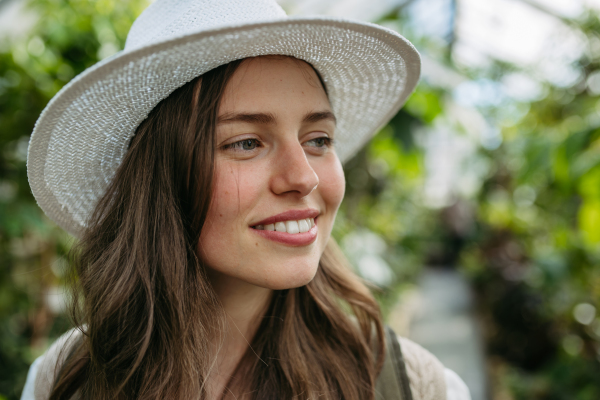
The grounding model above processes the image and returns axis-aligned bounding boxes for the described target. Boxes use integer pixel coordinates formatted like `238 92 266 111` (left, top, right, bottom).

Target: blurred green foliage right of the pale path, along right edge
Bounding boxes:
454 16 600 399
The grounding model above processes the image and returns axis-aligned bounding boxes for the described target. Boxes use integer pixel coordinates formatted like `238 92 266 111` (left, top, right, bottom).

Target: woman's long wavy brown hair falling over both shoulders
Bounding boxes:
50 60 384 400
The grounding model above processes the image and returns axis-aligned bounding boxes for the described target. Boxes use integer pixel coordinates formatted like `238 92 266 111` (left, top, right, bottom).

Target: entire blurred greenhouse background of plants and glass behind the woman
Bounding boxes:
0 0 600 400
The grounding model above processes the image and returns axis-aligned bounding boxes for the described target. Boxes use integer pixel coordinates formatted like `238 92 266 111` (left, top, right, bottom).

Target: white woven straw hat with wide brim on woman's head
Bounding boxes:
27 0 420 236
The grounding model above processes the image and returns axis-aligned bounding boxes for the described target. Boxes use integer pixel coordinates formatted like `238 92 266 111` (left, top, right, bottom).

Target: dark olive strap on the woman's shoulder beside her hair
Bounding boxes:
375 326 413 400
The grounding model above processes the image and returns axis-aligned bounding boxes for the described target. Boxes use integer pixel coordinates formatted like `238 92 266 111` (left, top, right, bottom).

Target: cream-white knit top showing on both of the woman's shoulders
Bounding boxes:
21 329 471 400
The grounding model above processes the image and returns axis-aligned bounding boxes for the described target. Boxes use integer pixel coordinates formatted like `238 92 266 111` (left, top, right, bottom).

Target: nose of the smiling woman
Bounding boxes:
271 143 319 197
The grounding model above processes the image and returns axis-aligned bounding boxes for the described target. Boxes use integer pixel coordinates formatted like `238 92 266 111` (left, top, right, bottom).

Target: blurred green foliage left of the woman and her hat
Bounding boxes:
0 0 146 399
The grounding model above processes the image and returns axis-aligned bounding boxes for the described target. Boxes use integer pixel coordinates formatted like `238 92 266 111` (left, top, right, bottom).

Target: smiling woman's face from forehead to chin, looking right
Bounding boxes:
198 57 345 289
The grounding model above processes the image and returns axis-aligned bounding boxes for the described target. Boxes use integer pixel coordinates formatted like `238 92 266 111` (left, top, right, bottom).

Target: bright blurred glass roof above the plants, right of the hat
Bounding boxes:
279 0 600 86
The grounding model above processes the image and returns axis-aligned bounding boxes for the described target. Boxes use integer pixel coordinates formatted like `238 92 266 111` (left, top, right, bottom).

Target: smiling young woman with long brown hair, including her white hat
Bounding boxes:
23 0 468 400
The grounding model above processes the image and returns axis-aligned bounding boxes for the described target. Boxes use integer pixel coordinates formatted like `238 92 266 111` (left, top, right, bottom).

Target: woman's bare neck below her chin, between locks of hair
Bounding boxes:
208 276 273 400
